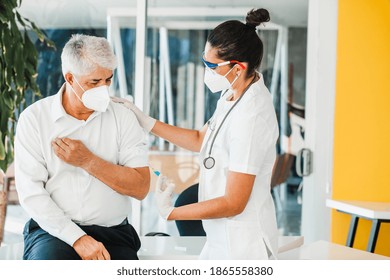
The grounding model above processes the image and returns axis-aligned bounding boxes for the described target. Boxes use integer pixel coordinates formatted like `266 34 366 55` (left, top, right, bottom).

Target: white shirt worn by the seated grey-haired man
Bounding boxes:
15 86 148 246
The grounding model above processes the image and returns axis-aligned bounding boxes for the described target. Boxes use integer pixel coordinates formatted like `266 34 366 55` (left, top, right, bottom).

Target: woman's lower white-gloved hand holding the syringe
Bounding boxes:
155 174 175 220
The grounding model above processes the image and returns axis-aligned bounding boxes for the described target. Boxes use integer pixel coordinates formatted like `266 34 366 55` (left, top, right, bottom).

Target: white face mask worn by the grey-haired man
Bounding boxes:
70 75 110 112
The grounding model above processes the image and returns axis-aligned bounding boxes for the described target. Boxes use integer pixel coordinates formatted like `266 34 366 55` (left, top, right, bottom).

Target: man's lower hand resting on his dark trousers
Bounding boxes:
73 235 111 260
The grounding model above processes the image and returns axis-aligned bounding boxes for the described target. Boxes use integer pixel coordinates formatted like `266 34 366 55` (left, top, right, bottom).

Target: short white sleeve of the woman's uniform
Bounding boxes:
228 114 275 175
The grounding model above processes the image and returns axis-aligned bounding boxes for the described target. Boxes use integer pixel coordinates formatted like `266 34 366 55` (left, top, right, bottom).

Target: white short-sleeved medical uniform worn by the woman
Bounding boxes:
199 75 279 259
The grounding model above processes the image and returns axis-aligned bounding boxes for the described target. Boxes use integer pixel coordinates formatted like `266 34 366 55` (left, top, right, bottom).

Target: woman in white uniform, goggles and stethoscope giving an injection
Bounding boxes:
114 9 279 259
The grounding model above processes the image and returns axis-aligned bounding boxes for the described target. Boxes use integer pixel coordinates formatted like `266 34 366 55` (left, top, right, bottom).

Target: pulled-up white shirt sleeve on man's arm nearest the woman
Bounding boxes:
118 110 148 168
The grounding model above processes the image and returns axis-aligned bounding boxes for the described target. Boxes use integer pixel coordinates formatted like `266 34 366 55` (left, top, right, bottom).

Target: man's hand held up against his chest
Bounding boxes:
51 138 94 168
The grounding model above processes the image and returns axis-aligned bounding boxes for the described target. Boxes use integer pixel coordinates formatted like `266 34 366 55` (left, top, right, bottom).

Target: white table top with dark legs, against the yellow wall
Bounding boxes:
326 199 390 220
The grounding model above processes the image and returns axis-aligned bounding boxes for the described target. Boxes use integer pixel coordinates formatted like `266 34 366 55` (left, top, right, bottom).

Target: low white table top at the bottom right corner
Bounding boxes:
278 240 390 260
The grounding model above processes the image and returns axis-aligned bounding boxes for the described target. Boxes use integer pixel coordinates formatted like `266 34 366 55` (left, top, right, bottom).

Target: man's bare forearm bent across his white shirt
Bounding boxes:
81 155 150 200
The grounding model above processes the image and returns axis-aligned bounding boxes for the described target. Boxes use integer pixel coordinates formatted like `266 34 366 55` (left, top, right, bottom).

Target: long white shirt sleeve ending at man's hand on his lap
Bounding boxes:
15 112 85 246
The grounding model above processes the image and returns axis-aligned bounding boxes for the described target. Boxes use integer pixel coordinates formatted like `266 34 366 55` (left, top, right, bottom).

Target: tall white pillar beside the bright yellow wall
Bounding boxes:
301 0 338 243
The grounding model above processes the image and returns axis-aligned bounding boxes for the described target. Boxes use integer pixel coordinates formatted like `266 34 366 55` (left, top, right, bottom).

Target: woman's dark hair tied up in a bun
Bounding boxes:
207 9 270 77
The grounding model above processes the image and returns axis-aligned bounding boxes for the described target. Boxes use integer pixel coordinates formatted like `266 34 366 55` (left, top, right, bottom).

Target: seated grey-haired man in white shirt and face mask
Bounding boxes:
15 35 150 260
